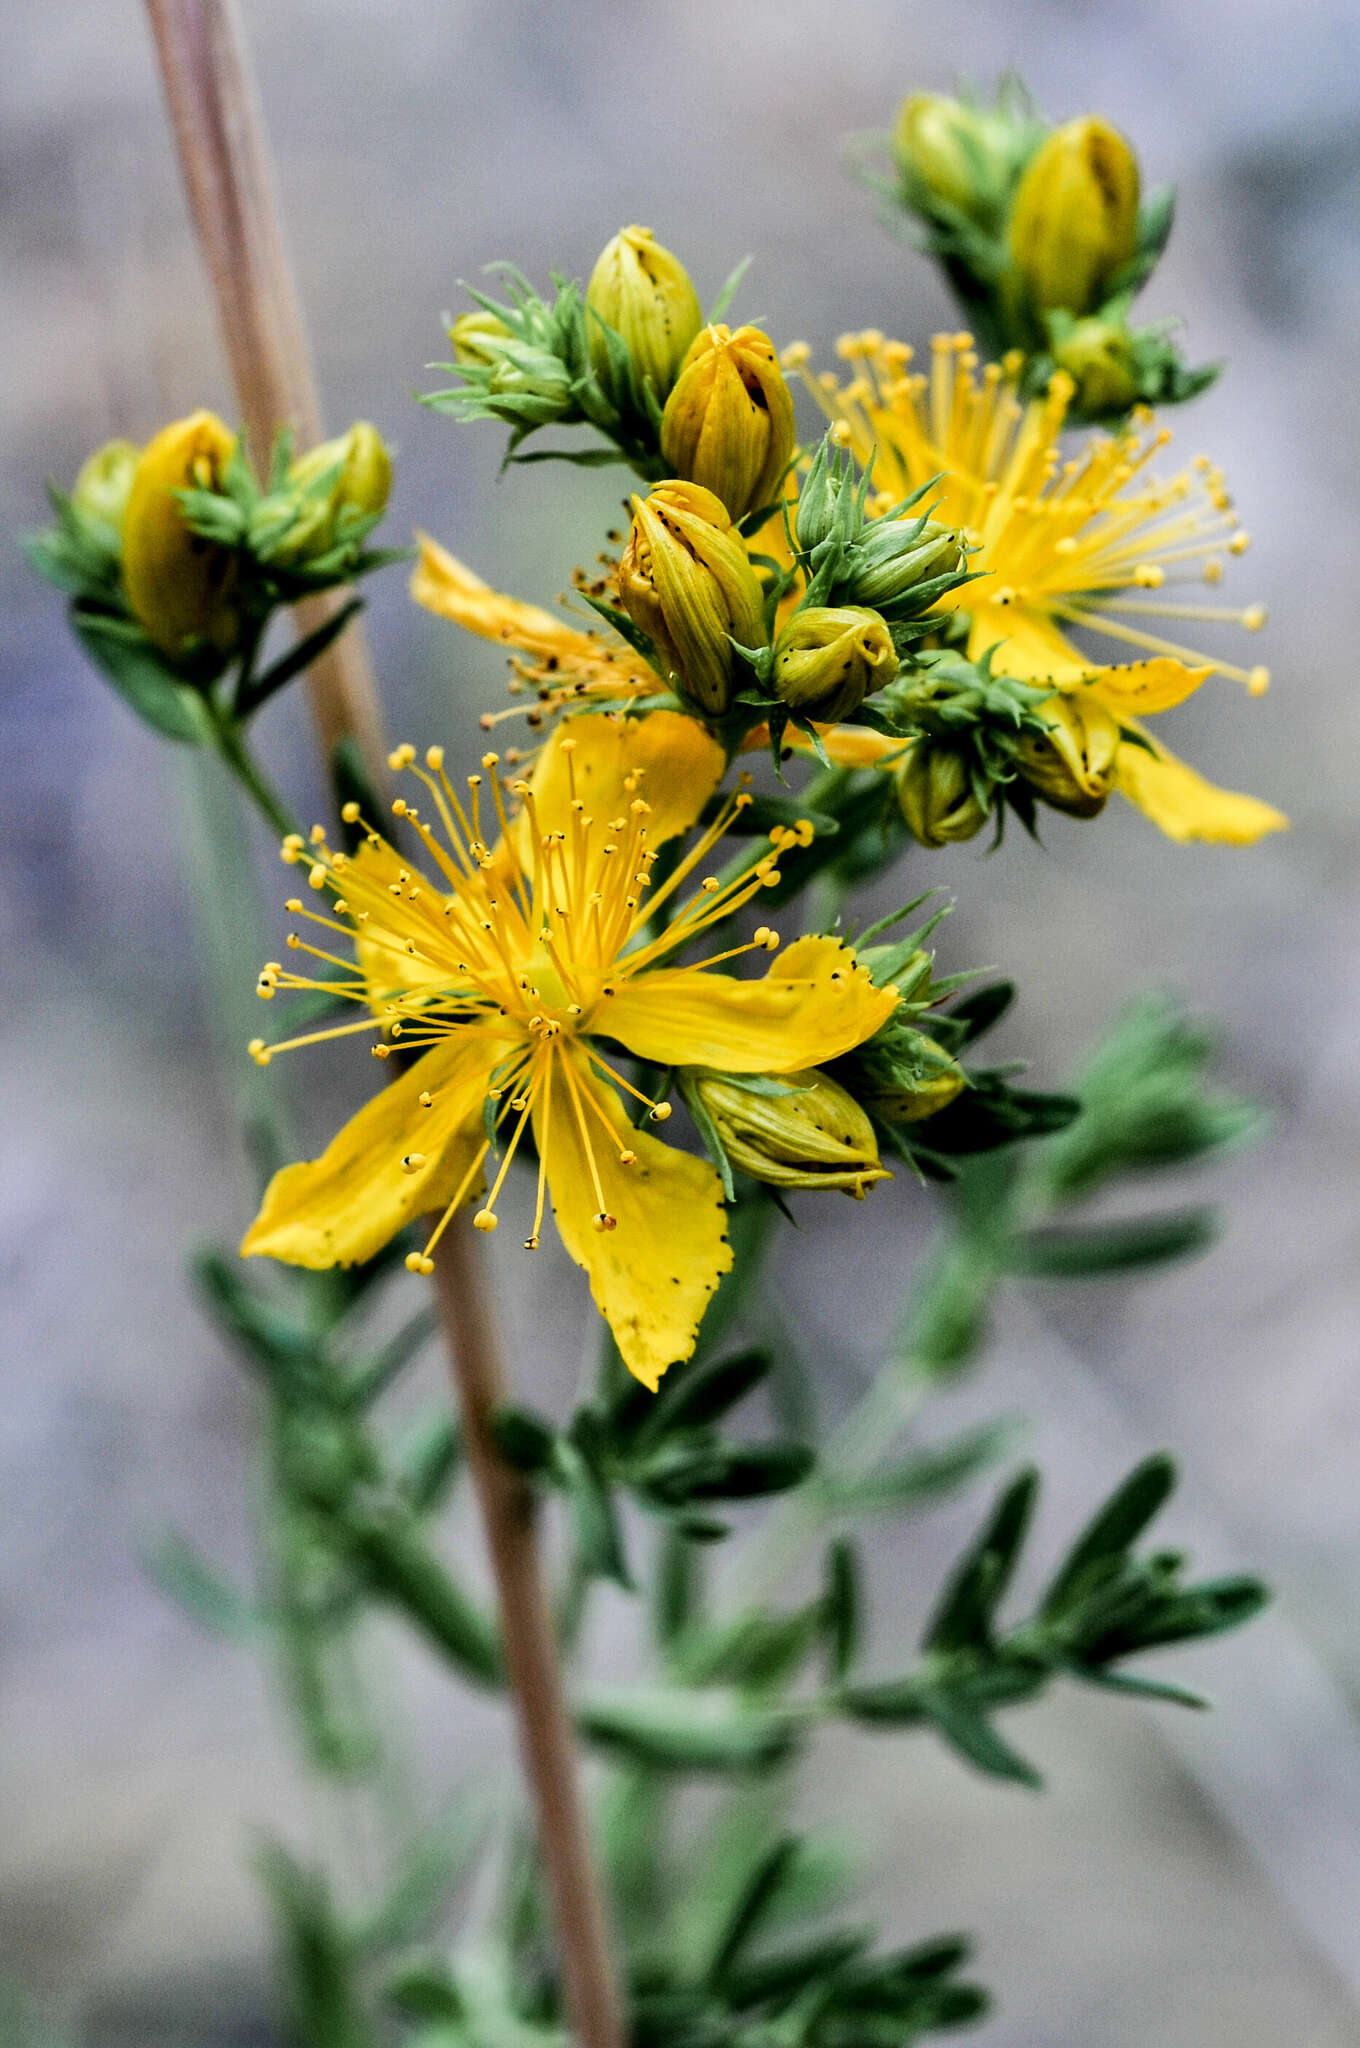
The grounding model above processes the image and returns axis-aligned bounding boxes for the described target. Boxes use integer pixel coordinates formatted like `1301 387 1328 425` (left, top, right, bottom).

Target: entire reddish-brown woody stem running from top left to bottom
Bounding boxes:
145 0 623 2048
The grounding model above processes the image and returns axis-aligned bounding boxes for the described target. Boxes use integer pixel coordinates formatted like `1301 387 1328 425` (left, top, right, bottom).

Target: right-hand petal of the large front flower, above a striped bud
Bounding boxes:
592 938 897 1073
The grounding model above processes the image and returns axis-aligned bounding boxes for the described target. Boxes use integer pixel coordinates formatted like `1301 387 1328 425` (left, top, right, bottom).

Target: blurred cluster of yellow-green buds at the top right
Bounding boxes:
891 80 1215 420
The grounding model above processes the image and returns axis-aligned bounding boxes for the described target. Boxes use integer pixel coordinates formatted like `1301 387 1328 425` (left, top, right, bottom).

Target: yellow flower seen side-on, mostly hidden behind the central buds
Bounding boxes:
412 532 666 731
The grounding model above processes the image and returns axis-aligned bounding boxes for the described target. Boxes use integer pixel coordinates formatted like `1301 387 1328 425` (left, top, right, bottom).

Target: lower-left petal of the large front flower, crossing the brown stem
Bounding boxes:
242 1030 504 1268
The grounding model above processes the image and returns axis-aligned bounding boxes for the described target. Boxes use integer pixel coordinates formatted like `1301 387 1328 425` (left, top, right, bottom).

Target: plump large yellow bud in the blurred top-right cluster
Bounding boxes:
1010 115 1139 313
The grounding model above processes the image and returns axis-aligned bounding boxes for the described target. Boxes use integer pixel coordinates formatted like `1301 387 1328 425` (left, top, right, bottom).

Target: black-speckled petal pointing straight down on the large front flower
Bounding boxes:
535 1047 731 1391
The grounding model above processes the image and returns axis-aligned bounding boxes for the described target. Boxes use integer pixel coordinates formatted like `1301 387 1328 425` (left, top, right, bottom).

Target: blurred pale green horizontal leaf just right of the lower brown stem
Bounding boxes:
576 1686 797 1772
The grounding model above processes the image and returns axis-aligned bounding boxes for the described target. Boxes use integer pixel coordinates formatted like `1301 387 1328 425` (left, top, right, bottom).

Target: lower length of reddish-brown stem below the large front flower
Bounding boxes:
434 1225 623 2048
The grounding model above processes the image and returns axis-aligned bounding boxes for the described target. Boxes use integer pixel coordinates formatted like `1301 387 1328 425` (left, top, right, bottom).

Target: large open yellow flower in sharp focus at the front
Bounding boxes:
242 713 897 1386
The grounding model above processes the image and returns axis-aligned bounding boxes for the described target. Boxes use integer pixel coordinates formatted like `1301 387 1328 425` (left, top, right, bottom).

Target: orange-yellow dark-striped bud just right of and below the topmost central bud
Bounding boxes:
662 326 797 520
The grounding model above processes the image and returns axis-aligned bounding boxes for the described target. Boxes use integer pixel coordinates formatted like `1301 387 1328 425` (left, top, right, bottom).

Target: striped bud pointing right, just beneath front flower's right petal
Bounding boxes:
692 1067 889 1200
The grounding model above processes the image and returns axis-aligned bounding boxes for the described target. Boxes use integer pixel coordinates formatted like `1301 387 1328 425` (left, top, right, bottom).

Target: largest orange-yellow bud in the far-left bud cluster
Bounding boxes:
123 412 240 662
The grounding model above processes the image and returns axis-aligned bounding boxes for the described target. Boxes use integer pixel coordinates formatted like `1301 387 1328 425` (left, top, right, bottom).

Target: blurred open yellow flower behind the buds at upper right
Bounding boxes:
787 332 1288 846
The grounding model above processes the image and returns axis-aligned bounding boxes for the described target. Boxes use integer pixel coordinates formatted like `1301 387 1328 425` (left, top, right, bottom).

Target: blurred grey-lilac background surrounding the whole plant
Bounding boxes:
0 0 1360 2048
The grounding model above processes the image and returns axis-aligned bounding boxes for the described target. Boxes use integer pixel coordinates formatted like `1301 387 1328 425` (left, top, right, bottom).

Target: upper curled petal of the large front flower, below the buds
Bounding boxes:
530 711 725 848
